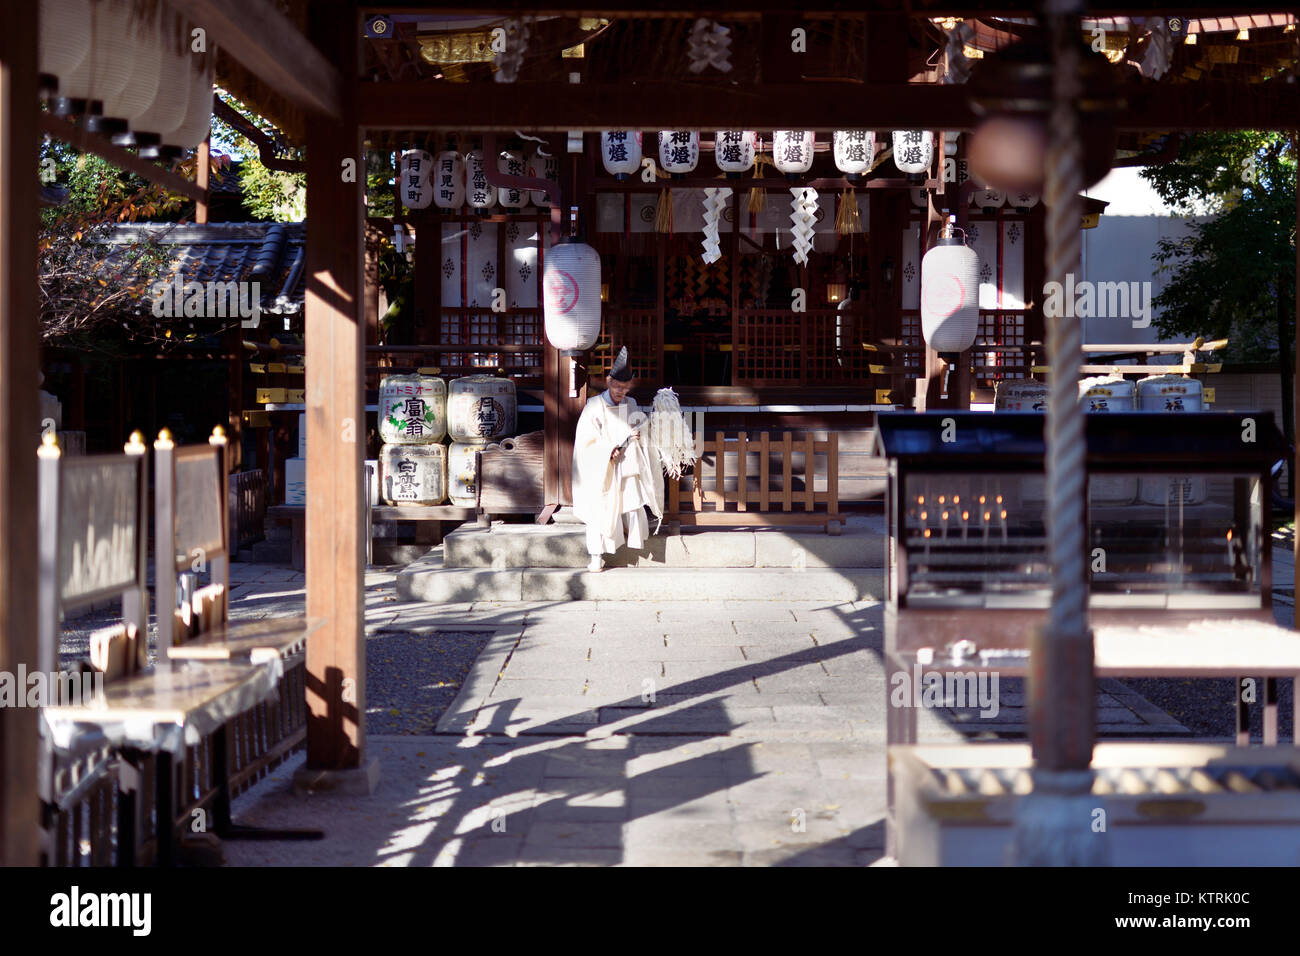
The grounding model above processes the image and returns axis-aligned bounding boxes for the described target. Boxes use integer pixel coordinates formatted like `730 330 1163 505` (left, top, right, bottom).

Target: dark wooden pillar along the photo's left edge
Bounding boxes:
0 5 40 866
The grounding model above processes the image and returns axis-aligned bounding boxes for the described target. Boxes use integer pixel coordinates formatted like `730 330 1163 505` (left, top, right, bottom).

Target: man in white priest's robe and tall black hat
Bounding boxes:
573 347 663 571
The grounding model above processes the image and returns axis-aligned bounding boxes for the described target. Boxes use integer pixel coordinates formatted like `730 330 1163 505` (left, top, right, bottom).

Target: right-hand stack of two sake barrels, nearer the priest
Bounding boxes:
447 375 519 506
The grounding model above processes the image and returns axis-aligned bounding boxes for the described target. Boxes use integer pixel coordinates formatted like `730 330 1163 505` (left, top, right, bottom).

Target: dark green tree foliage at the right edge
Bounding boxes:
1141 131 1296 363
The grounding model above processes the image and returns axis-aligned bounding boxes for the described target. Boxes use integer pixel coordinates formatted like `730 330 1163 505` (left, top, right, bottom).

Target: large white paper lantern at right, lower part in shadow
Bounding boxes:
920 216 979 364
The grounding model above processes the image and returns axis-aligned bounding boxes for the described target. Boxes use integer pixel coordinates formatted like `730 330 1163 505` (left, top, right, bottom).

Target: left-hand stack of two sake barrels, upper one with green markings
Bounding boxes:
380 375 447 505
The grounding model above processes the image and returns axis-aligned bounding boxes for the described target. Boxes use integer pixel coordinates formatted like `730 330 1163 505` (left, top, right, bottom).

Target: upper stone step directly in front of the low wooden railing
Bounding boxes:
443 516 887 571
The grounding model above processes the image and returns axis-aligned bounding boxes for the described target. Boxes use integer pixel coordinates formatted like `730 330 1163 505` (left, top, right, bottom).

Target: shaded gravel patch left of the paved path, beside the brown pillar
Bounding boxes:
365 628 493 735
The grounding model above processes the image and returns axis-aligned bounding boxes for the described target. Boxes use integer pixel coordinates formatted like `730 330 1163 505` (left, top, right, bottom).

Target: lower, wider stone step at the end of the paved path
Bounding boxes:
397 554 884 604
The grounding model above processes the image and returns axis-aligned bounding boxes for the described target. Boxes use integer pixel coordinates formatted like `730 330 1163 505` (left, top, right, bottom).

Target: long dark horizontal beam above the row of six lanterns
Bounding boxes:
358 81 1300 131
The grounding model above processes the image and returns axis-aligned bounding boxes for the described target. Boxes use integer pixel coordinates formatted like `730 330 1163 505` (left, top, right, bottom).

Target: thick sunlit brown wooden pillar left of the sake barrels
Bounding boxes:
306 1 365 771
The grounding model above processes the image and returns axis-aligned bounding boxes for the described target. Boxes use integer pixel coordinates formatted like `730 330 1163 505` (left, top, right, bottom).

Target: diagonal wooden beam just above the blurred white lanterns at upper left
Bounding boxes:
172 0 345 120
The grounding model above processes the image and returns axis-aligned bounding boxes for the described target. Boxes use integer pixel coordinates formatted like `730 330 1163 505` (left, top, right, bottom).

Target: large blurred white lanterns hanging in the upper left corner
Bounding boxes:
36 0 216 159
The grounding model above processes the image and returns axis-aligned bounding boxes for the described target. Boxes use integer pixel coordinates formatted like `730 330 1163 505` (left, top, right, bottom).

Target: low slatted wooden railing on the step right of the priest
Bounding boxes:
664 432 844 535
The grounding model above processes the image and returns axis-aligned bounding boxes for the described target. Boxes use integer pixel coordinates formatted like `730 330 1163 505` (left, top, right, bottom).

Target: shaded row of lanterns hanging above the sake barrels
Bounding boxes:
398 147 560 209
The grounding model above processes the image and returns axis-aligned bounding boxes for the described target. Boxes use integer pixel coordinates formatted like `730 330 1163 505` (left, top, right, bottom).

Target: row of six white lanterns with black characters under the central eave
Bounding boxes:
601 130 935 181
